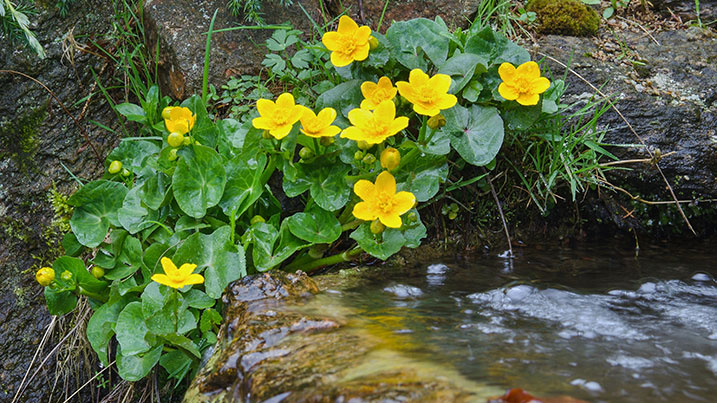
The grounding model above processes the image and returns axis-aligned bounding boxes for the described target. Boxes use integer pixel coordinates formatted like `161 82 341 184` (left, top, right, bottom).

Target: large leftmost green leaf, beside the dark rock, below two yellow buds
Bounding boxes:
68 180 127 248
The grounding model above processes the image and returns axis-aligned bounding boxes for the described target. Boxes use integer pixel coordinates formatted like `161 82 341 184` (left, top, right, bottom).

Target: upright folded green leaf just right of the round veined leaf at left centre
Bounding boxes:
219 154 267 218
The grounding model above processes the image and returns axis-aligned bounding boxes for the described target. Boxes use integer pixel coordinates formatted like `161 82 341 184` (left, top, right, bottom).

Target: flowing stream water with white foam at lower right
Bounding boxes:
321 244 717 402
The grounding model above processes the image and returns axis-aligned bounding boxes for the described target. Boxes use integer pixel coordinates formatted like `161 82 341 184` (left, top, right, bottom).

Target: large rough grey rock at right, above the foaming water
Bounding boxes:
535 28 717 234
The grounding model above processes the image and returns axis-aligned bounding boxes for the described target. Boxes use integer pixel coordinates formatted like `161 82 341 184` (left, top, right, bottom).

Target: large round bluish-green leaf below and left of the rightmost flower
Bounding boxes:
444 105 503 166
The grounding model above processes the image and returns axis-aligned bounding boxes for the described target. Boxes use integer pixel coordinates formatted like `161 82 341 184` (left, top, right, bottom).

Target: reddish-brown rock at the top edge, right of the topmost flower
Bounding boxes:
327 0 480 33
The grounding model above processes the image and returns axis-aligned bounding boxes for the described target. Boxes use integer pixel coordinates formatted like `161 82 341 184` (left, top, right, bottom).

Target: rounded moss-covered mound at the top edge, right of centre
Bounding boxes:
527 0 600 36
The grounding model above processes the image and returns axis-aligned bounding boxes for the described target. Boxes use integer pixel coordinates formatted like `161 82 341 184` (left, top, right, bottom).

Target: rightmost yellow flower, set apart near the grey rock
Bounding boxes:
498 61 550 105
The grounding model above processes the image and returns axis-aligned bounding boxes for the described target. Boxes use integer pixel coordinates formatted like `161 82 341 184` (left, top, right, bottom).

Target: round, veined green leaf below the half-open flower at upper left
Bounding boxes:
172 145 226 218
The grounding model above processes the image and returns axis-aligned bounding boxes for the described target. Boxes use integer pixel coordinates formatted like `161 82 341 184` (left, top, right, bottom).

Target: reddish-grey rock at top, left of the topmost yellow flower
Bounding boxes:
144 0 321 99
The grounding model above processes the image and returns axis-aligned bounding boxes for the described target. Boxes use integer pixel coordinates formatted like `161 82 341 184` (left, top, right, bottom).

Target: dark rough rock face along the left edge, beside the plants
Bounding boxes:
0 0 116 402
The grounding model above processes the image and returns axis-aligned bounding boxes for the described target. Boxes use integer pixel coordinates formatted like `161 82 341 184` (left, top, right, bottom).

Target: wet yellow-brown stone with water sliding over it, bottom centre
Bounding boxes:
184 270 495 402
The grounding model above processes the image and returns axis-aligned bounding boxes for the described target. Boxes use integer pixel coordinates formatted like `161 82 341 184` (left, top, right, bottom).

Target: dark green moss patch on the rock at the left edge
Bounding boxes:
0 107 46 170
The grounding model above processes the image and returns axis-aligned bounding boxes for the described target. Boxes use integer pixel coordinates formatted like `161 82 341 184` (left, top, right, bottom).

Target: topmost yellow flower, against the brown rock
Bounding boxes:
321 15 371 67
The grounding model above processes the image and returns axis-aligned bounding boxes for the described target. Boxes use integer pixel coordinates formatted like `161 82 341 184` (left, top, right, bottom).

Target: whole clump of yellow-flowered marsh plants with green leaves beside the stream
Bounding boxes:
36 16 576 388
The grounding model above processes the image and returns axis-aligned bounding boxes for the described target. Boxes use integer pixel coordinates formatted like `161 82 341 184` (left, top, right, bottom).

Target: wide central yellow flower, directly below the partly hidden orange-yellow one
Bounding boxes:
341 101 408 145
